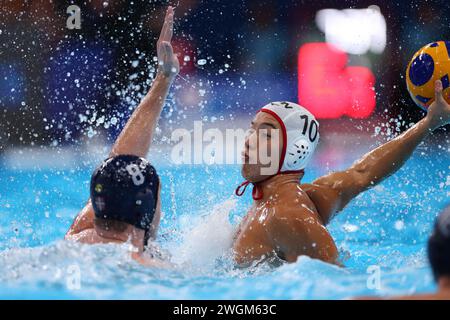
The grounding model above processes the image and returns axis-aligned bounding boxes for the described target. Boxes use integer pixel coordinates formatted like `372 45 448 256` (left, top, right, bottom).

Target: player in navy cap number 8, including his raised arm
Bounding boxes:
66 7 179 267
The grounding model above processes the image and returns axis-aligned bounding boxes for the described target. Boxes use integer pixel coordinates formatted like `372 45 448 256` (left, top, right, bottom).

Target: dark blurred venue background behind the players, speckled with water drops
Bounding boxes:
0 0 450 152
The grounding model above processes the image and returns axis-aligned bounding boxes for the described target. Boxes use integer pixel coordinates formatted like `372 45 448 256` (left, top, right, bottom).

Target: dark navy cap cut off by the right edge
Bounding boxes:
428 206 450 281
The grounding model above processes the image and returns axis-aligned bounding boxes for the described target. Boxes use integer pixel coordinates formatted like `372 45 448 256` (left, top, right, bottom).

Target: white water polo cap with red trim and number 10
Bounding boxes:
236 101 319 200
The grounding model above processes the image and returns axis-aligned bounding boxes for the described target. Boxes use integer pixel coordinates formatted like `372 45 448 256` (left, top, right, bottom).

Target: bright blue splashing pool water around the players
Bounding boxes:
0 146 450 299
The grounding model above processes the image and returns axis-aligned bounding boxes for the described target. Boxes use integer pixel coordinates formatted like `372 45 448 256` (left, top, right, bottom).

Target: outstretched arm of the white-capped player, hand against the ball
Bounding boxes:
306 81 450 223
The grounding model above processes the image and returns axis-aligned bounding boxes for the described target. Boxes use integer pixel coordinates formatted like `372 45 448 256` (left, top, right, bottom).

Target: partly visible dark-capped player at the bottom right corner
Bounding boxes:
358 206 450 300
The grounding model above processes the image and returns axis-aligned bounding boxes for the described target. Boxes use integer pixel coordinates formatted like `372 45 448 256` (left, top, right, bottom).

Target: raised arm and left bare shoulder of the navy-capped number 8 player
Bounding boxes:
66 7 180 238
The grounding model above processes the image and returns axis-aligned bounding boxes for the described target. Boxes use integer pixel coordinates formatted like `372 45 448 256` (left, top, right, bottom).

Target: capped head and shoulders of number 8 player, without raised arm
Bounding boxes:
67 155 164 265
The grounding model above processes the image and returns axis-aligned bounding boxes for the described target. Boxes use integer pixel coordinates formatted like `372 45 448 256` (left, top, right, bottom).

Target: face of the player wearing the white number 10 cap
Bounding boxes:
241 112 283 183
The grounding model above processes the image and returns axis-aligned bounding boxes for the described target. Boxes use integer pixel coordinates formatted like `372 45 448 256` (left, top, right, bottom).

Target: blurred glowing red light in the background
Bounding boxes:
298 43 376 119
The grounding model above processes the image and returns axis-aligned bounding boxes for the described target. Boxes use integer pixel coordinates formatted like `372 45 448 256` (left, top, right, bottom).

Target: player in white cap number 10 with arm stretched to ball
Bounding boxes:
233 81 450 266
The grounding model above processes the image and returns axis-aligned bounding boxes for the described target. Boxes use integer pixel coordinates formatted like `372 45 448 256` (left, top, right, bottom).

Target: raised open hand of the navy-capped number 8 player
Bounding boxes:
157 6 180 80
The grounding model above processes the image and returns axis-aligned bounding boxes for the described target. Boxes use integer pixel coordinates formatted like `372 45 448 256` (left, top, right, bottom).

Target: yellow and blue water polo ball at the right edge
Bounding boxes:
406 41 450 110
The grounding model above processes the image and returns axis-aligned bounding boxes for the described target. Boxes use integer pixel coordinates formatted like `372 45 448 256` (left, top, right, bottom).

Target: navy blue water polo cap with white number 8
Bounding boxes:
90 155 159 232
